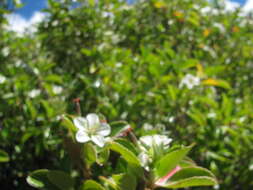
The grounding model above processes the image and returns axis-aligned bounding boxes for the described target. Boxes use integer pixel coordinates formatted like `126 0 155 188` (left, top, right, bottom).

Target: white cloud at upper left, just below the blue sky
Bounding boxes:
6 11 46 35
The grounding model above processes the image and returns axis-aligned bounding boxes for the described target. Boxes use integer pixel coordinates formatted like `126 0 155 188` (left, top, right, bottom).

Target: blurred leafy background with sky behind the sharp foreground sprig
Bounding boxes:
0 0 253 190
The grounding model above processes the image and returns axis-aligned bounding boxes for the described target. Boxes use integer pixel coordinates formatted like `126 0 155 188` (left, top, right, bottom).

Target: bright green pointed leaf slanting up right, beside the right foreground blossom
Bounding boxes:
155 145 193 178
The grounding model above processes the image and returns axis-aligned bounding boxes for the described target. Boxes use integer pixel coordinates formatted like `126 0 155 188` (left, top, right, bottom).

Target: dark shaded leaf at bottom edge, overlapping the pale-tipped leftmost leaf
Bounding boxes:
47 170 74 190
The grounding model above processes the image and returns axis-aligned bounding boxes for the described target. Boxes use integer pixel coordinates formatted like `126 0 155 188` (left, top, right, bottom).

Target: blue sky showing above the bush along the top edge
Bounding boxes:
16 0 247 19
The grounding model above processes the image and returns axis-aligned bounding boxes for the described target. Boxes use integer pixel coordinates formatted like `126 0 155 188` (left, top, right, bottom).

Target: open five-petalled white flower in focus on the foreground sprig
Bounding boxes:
74 113 111 147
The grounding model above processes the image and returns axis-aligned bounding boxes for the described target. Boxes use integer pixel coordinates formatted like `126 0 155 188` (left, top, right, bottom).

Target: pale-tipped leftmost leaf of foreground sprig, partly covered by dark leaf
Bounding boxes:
26 169 59 190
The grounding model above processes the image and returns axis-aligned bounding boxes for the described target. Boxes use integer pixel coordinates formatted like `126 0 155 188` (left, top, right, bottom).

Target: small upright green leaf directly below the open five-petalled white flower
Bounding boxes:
82 143 97 165
